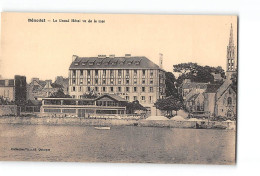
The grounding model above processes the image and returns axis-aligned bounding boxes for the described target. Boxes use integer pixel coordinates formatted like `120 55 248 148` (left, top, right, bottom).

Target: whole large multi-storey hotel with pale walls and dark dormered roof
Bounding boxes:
69 54 166 107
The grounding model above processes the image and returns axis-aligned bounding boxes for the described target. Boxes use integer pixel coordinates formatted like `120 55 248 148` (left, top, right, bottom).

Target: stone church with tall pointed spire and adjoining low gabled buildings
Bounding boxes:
182 24 237 119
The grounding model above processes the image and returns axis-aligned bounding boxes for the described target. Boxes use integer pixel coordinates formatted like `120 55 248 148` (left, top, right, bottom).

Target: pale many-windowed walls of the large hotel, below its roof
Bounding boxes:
69 68 165 107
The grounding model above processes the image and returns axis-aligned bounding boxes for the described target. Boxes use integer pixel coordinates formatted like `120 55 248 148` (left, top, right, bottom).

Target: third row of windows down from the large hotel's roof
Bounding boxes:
71 86 153 92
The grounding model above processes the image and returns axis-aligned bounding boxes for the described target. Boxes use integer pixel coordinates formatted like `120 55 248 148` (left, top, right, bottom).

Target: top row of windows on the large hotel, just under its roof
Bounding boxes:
72 69 153 76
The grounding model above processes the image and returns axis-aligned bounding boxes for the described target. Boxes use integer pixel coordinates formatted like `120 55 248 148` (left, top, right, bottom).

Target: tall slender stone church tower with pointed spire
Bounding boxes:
227 24 237 80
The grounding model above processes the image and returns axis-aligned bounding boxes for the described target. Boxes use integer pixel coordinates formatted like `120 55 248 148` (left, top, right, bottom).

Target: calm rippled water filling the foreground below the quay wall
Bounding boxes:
0 124 235 164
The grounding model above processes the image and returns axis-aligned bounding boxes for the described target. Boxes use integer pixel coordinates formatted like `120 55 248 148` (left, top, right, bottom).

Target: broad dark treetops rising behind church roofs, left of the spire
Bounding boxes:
173 62 225 84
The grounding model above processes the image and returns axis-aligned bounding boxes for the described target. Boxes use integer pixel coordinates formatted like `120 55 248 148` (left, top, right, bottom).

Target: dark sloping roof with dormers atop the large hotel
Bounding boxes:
69 56 160 69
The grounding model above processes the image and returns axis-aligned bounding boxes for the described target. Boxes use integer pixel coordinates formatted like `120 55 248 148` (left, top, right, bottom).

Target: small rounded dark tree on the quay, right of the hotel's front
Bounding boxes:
154 96 183 117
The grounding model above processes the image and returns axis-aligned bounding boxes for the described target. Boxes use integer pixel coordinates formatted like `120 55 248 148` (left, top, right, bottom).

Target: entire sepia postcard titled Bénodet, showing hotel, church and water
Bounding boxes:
0 12 238 165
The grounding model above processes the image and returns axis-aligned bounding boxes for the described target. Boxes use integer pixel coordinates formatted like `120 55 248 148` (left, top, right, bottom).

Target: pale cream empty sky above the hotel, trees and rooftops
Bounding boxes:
0 13 237 82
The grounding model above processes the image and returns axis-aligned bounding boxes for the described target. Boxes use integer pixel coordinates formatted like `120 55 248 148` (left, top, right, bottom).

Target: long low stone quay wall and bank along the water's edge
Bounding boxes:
0 117 236 130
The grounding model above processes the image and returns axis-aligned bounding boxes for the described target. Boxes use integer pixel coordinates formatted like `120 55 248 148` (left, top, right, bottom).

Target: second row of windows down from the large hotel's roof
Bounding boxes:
72 78 153 84
